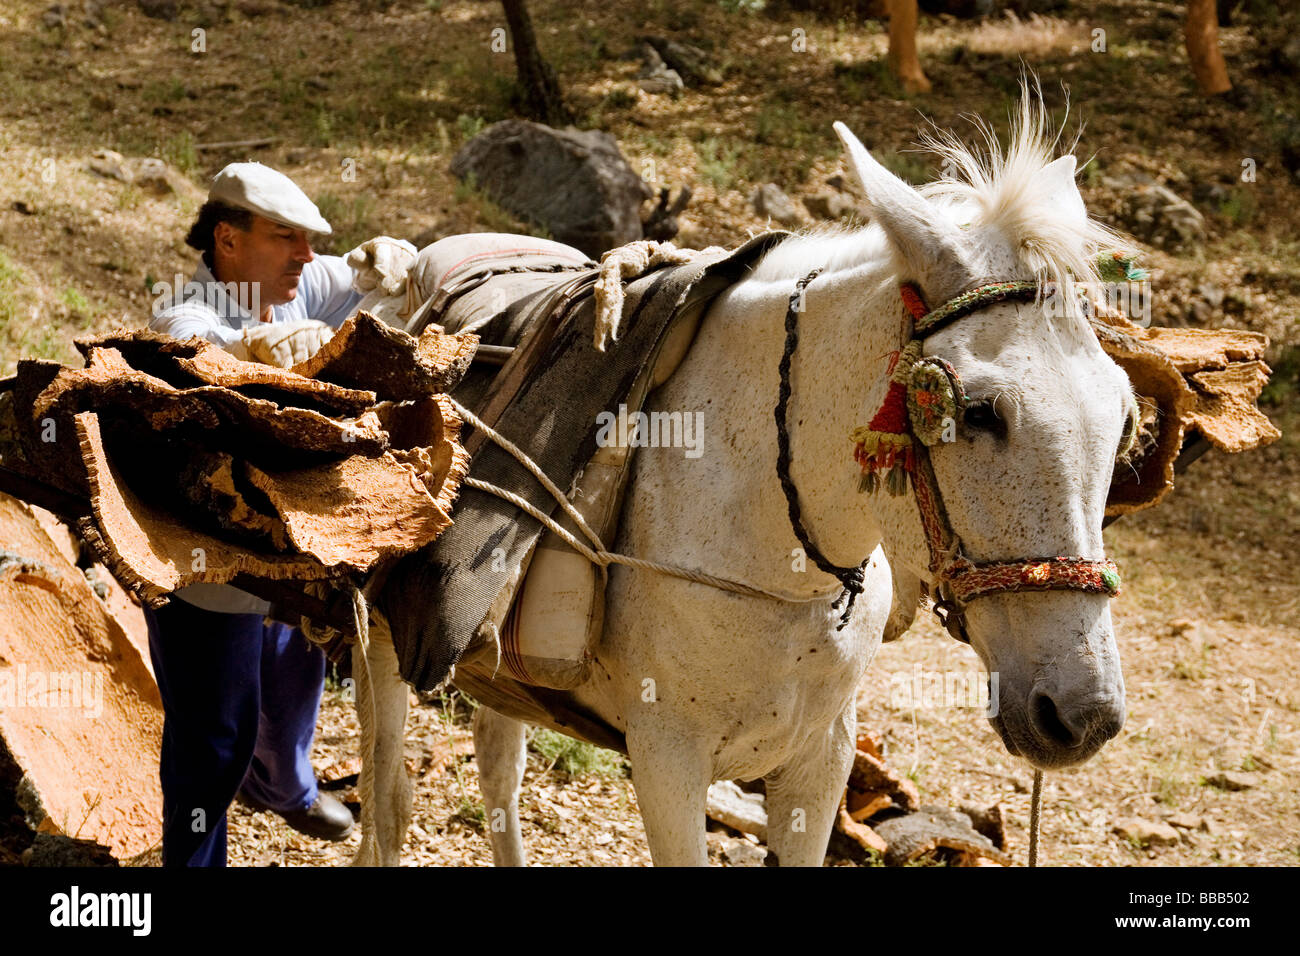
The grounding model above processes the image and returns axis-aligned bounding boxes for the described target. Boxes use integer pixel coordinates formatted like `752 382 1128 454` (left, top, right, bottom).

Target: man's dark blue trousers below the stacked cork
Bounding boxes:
144 598 325 866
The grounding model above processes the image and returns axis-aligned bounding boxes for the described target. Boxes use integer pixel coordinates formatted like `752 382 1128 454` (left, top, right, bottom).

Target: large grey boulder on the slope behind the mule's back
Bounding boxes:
451 120 654 259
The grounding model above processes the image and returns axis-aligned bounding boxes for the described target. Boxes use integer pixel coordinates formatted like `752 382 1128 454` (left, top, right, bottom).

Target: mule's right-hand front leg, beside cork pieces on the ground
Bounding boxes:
763 700 857 866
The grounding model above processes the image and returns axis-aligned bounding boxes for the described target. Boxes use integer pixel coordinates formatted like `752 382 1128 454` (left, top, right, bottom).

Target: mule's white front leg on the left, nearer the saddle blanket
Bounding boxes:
628 726 712 866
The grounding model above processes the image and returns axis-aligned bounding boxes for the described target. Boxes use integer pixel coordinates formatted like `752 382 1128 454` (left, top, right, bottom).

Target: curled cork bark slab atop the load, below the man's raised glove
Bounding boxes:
290 312 478 402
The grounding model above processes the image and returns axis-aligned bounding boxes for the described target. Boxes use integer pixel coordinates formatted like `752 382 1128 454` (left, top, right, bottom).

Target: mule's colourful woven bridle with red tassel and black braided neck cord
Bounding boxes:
776 269 1119 644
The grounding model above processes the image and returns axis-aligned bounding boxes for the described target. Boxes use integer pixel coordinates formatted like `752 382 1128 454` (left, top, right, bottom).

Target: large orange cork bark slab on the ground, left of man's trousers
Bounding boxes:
0 496 163 858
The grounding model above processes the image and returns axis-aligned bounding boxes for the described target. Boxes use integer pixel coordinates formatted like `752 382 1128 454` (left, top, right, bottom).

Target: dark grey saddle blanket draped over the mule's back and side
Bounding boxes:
378 233 787 691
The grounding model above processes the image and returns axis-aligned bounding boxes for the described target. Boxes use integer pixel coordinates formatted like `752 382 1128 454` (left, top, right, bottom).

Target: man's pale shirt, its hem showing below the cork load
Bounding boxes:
150 256 363 614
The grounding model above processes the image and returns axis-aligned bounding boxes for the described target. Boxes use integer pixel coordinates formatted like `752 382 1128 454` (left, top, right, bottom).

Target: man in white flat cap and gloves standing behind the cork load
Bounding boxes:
146 163 415 866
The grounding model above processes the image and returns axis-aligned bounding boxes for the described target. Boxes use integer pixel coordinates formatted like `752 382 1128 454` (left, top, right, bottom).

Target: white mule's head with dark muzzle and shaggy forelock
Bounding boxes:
836 114 1135 769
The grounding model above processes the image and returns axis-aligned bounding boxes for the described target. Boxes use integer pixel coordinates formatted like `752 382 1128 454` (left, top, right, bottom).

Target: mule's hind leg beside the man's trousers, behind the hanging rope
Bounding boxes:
352 615 411 866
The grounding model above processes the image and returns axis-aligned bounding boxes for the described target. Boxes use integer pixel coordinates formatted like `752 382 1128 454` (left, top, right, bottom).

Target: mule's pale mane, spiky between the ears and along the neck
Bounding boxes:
754 92 1127 303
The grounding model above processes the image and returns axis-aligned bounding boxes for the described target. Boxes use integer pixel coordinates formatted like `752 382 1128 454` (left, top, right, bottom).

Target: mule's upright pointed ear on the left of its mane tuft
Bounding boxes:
835 122 970 299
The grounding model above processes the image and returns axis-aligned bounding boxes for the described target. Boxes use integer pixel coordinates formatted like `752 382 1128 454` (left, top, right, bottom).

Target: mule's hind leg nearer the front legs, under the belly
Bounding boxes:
475 706 528 866
